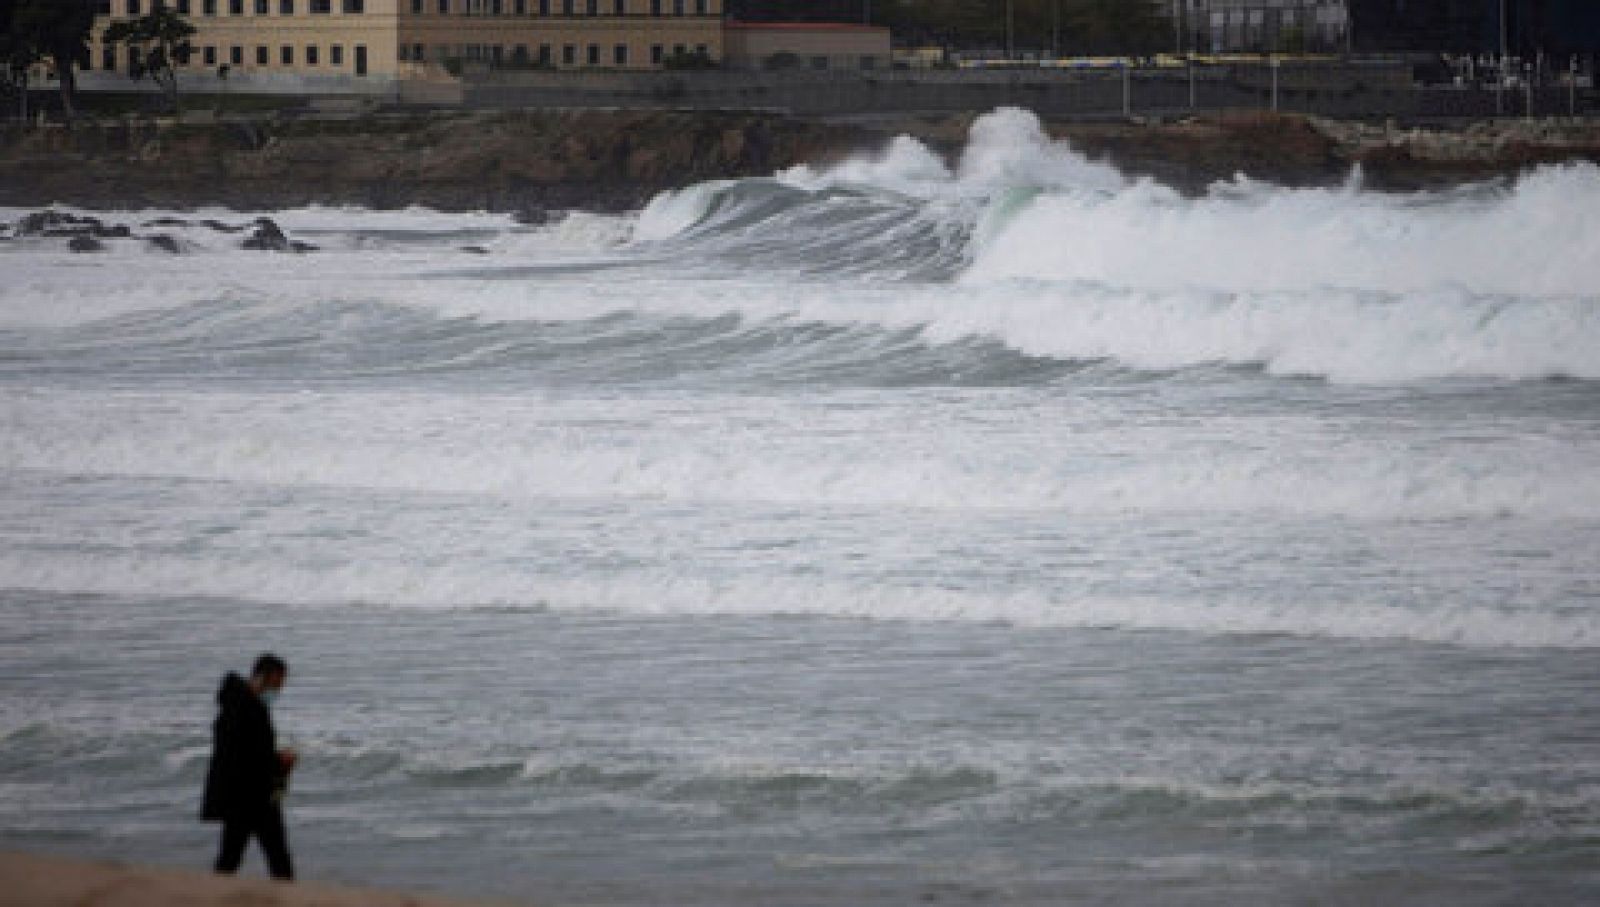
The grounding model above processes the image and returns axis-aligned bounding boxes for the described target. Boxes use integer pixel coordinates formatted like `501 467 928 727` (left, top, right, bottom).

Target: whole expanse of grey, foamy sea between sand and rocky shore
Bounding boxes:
0 110 1600 905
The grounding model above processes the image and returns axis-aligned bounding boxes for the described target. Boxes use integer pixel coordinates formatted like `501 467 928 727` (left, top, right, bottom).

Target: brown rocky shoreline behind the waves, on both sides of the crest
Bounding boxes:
0 109 1600 219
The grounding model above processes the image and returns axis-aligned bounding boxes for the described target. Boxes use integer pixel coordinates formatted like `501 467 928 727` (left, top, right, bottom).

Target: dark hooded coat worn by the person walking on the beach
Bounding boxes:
200 673 283 821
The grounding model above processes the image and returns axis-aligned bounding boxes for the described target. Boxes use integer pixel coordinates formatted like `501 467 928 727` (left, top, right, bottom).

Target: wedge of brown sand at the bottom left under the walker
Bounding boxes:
0 853 524 907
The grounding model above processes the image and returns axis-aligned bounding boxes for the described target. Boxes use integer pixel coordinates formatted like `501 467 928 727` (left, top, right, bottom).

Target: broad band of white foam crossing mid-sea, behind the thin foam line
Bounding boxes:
0 392 1600 520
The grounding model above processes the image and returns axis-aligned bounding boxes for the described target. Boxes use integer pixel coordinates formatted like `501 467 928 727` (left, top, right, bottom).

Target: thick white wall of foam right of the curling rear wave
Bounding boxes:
965 163 1600 299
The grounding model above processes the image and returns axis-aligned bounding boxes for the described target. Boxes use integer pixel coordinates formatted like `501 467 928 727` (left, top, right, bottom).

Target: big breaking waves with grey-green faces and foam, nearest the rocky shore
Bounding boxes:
0 110 1600 386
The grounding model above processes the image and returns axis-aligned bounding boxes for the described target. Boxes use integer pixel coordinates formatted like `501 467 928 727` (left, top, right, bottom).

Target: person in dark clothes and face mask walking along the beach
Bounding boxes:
200 654 294 881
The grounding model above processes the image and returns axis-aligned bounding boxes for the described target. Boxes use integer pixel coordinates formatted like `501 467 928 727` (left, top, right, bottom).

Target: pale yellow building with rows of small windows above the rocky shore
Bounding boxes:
86 0 723 82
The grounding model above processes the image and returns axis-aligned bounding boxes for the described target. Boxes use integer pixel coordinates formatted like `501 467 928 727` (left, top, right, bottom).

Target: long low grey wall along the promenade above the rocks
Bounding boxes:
461 64 1597 120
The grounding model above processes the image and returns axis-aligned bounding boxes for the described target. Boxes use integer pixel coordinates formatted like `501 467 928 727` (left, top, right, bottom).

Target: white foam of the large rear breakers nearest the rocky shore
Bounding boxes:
0 110 1600 382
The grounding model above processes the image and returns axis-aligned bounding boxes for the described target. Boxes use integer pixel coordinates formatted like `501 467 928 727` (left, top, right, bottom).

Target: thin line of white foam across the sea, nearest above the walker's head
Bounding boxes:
0 553 1600 648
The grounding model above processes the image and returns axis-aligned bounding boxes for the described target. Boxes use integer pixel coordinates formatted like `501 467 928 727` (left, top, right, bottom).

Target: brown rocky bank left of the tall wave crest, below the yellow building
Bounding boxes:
0 110 875 218
